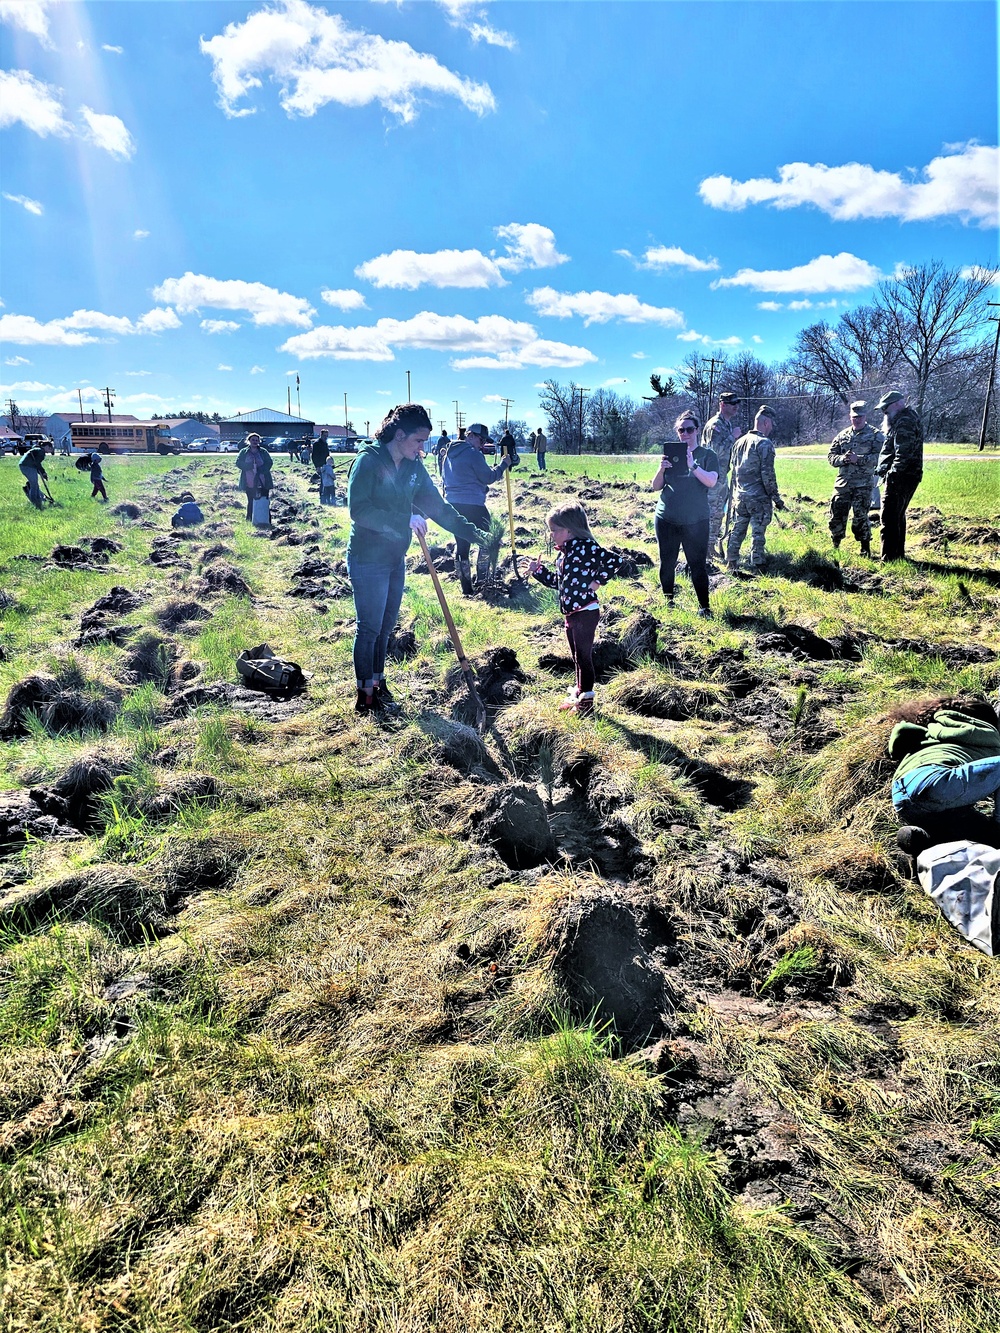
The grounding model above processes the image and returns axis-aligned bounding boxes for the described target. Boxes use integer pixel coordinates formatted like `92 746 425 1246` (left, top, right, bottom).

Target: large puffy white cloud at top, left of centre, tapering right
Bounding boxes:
201 0 496 121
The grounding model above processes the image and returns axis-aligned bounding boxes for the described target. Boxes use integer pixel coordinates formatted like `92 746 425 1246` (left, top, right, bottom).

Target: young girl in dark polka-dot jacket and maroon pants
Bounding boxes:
528 504 623 716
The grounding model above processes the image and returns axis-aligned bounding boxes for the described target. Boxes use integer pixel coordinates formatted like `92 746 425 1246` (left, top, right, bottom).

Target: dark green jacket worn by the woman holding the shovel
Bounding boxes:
347 440 488 565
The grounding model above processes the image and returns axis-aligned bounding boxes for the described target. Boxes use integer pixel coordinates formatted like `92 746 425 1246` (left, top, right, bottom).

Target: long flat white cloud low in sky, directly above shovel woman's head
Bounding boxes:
279 311 596 369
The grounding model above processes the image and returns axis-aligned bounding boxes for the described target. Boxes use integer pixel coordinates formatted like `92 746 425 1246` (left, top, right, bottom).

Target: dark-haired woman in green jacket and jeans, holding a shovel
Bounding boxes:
347 403 487 714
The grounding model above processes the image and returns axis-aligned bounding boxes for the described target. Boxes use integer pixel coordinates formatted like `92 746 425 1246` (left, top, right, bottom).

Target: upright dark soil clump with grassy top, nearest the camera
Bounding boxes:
547 888 679 1050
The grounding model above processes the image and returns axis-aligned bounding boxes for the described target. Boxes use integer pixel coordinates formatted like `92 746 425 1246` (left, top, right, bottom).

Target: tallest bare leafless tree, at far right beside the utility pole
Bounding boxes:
876 260 999 416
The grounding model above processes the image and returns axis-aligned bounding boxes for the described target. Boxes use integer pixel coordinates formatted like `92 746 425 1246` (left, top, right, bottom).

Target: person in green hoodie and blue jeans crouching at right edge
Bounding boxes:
889 696 1000 856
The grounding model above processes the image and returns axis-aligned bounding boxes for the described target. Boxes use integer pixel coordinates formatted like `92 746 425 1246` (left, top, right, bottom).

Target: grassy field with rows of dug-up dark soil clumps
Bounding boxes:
0 455 1000 1333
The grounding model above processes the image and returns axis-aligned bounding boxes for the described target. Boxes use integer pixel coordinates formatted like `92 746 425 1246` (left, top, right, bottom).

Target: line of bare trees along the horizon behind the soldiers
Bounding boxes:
539 260 1000 453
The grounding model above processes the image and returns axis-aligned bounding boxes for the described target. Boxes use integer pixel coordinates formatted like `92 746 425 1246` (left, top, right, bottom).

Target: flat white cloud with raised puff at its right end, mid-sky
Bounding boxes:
355 223 569 292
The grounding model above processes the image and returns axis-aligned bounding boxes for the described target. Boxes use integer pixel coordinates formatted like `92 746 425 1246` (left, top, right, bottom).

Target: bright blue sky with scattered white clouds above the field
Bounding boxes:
0 0 997 428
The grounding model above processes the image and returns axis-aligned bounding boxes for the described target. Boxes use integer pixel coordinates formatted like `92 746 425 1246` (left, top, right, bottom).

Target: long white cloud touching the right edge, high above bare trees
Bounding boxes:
700 140 1000 227
